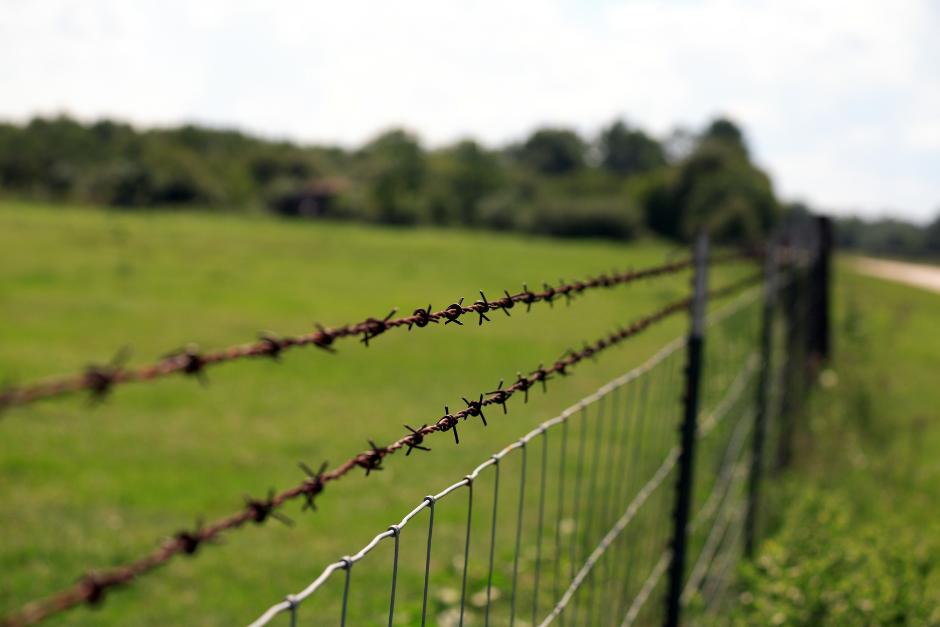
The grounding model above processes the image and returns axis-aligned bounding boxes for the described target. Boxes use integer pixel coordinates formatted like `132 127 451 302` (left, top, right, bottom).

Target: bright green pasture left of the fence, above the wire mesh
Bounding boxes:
0 203 756 625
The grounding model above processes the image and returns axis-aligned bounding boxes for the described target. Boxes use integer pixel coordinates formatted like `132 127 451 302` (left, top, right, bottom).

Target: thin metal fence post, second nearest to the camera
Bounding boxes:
744 240 777 558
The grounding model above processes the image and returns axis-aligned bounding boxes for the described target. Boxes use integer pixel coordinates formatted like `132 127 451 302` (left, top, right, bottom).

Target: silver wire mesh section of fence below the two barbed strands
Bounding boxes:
252 218 828 626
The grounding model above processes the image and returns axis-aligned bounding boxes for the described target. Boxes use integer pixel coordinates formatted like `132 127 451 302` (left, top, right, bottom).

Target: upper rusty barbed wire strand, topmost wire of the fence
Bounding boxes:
0 251 756 411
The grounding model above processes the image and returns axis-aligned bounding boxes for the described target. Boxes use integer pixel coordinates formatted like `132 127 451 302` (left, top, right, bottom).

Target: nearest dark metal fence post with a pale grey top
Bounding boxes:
664 234 708 627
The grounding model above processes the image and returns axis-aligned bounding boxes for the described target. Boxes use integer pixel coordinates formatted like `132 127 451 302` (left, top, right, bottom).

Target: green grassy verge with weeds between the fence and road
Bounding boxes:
717 268 940 625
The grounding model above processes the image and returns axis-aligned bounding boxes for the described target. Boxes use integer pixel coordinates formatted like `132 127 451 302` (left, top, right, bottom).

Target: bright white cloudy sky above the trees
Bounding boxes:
0 0 940 221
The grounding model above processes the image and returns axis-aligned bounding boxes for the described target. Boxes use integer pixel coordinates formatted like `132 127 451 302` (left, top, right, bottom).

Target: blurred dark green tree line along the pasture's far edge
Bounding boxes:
0 116 808 247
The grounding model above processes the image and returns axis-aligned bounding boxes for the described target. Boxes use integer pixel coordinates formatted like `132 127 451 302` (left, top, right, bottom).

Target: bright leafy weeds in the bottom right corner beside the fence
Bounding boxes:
723 494 940 625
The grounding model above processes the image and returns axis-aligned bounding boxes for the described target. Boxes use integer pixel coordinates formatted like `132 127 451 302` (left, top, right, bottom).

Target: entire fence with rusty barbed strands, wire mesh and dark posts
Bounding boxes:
0 219 831 626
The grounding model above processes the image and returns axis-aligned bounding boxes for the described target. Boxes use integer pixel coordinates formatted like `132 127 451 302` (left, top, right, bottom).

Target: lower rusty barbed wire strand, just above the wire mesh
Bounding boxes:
0 273 763 627
